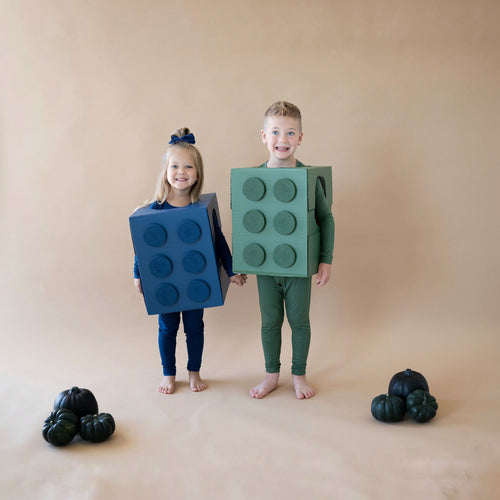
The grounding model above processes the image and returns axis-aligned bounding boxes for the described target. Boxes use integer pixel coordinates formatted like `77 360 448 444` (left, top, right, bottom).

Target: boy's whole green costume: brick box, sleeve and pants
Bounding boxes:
231 161 335 375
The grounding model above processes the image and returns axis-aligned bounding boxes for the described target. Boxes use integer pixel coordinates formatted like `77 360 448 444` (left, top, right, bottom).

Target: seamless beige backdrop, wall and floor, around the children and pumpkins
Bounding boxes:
0 0 500 499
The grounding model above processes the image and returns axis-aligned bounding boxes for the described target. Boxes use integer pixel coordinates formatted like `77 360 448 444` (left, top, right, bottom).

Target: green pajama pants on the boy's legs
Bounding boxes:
257 275 311 375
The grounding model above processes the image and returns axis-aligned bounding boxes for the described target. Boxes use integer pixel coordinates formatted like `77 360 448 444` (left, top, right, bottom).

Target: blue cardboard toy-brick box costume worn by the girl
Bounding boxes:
129 193 229 314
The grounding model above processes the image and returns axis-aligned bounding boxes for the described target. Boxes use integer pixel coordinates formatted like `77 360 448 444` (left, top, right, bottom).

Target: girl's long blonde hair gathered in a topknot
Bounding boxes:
136 127 203 210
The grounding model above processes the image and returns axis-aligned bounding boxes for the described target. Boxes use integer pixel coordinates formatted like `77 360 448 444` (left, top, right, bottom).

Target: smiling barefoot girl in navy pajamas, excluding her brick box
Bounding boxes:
134 128 246 394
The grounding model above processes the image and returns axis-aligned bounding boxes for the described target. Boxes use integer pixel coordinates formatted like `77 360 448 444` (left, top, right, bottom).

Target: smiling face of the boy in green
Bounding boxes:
261 116 302 162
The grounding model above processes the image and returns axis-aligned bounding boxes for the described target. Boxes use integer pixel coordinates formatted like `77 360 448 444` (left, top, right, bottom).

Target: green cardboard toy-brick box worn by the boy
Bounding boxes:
231 166 333 277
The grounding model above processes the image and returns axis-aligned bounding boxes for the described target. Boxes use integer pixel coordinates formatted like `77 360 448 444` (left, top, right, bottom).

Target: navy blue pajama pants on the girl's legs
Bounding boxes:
158 309 204 375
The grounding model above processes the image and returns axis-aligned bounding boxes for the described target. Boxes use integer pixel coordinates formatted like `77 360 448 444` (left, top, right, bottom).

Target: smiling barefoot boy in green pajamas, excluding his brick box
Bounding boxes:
250 101 335 399
